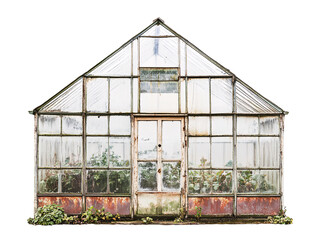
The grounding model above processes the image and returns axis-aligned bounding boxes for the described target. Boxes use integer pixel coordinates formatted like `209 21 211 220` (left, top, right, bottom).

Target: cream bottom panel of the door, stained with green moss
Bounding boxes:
137 193 181 215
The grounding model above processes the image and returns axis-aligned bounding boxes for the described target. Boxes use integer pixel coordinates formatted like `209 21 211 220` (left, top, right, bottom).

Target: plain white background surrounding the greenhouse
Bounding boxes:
0 0 319 239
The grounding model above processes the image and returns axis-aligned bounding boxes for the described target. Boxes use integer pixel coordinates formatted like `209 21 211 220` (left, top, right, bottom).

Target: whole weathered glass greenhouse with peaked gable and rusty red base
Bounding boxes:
30 18 287 218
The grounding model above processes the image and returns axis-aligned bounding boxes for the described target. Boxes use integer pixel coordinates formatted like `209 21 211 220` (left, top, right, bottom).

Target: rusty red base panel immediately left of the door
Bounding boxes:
86 197 131 216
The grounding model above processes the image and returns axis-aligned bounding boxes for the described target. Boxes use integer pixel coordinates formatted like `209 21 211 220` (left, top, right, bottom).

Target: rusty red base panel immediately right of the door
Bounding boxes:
188 197 233 215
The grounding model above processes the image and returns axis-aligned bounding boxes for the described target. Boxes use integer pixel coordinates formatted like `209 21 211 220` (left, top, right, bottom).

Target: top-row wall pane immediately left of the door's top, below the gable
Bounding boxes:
110 116 131 135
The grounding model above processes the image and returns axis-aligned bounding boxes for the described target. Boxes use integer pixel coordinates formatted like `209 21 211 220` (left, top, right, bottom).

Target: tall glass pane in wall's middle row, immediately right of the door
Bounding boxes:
188 137 210 168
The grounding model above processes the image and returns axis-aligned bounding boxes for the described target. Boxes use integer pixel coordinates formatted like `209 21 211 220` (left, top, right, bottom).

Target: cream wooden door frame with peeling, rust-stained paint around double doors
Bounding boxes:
131 115 187 218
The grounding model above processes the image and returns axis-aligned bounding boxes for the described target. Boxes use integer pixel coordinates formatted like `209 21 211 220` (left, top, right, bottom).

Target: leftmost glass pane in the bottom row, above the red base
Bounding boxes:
38 170 59 193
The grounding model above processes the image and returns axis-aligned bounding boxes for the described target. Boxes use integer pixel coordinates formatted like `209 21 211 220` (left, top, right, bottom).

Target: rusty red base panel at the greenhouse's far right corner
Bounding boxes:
237 197 280 215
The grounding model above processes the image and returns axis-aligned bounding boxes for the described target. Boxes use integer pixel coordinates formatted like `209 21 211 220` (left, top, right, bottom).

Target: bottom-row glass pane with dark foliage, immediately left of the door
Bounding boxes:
109 170 131 193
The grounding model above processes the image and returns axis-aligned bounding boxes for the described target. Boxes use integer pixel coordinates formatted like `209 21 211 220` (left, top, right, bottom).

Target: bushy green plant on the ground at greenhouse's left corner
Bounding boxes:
28 204 64 225
